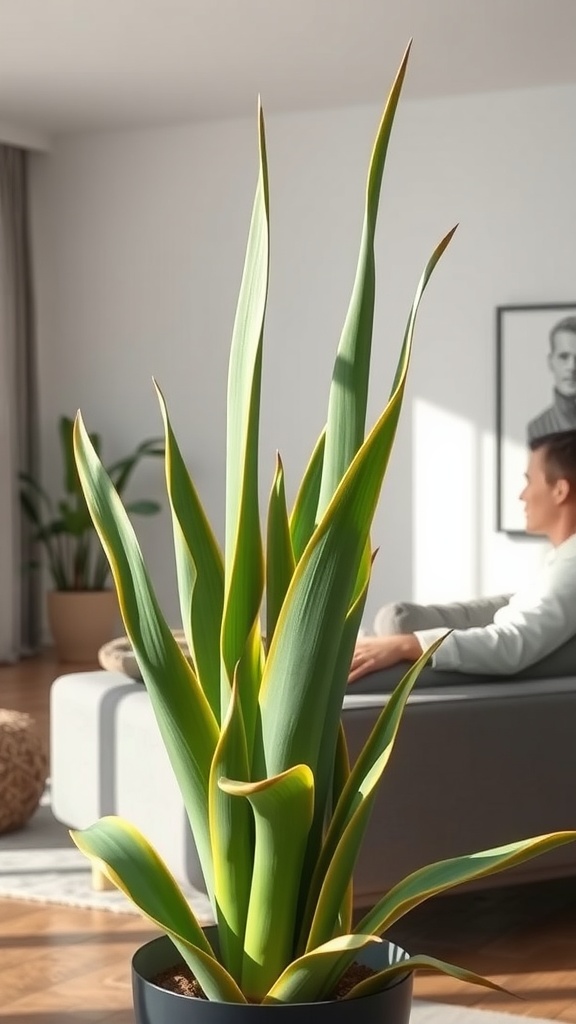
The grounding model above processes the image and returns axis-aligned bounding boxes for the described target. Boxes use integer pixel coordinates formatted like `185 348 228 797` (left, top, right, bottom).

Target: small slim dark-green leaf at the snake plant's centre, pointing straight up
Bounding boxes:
266 455 294 643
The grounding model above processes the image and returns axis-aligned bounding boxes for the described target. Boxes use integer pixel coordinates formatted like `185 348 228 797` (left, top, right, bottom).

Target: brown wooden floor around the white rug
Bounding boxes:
0 654 576 1024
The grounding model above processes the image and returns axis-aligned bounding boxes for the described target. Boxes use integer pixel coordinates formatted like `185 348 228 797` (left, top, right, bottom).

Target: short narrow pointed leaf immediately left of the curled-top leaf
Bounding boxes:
209 683 250 983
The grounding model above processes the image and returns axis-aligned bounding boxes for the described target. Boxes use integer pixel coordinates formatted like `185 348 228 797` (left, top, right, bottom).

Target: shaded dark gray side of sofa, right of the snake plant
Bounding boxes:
343 673 576 905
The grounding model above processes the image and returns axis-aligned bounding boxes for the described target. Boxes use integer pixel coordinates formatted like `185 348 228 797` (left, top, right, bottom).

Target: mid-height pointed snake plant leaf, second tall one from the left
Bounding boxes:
155 382 224 721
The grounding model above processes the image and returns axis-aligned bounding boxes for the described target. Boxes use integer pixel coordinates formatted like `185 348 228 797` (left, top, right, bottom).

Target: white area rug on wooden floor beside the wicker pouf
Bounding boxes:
0 795 212 925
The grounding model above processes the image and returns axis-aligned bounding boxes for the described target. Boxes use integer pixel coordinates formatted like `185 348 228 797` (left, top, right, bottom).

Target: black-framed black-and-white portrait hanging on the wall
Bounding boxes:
496 302 576 534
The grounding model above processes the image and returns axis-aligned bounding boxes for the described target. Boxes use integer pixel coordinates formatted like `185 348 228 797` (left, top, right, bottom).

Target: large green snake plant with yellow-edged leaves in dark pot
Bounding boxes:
68 44 576 1004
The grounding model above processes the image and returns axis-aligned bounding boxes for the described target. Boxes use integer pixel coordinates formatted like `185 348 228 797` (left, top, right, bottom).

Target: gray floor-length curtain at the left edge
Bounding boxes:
0 145 40 662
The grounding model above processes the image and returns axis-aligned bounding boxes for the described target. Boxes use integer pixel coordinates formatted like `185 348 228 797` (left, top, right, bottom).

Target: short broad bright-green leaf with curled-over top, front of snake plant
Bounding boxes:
219 764 314 1001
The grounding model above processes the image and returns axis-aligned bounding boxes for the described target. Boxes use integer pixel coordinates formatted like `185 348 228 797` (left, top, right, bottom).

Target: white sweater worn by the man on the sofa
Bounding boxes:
415 535 576 675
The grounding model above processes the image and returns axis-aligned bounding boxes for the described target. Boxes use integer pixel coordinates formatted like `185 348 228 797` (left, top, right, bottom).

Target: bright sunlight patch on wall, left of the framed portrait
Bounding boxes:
412 398 480 602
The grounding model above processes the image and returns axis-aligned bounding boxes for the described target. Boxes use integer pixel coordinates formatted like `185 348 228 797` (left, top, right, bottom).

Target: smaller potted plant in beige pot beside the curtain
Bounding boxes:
19 416 164 662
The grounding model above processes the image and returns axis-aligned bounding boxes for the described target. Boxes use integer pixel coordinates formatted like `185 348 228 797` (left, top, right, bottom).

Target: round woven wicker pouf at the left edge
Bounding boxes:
0 708 48 834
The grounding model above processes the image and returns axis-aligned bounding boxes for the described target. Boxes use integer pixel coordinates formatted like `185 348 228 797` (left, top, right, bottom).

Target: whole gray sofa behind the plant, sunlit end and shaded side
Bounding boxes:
51 670 576 905
